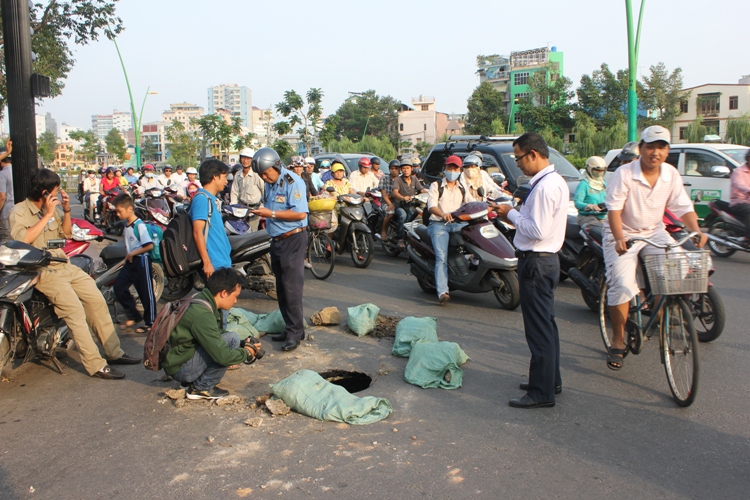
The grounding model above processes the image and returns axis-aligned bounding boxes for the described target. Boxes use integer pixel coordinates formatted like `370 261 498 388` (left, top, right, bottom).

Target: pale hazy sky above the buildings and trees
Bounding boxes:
27 0 750 129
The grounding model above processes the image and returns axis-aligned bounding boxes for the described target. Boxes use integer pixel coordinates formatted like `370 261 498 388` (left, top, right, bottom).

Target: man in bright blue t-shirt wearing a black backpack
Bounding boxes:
190 160 232 279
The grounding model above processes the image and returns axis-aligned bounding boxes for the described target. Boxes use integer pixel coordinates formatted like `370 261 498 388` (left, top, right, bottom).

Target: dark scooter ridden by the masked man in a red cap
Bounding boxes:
406 202 521 310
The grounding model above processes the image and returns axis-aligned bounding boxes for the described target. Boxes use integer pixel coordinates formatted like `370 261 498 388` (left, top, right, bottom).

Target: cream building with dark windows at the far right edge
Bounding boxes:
672 75 750 143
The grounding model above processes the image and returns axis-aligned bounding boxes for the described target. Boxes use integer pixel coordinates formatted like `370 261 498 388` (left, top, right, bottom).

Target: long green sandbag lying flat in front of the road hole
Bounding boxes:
271 370 393 425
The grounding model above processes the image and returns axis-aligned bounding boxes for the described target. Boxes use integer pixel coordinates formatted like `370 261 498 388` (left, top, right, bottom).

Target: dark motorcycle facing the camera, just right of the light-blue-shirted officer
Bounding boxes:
327 187 375 268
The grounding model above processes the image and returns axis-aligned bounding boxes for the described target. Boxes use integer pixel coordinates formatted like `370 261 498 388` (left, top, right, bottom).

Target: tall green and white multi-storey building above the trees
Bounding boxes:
477 47 565 122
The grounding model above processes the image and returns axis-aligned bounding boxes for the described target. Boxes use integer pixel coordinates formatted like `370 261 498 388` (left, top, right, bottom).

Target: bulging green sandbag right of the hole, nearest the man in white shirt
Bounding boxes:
404 340 469 389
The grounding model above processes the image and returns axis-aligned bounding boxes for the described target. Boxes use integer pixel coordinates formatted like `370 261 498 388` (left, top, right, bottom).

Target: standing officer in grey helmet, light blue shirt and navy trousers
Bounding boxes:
252 148 307 351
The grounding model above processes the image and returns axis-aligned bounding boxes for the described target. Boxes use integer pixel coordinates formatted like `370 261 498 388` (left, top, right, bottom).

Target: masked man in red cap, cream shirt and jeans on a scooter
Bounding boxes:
427 155 467 306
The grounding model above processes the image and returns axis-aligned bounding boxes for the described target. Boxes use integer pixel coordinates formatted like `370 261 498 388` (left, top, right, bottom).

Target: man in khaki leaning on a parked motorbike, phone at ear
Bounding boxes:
10 168 141 379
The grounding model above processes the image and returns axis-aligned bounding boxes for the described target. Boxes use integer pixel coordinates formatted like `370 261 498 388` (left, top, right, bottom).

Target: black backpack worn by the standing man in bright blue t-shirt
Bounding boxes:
161 193 214 278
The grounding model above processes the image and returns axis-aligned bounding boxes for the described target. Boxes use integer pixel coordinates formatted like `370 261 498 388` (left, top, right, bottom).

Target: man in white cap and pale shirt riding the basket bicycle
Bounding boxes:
604 125 707 370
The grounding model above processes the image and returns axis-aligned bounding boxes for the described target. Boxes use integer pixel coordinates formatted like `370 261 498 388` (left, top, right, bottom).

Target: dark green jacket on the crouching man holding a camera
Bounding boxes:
162 288 247 375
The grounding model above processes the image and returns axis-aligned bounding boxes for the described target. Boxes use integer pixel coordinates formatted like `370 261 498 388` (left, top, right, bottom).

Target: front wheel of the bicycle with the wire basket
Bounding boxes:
661 297 699 406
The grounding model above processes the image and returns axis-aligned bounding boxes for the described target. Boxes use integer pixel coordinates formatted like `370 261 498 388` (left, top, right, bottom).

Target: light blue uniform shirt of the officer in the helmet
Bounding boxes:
263 168 308 238
